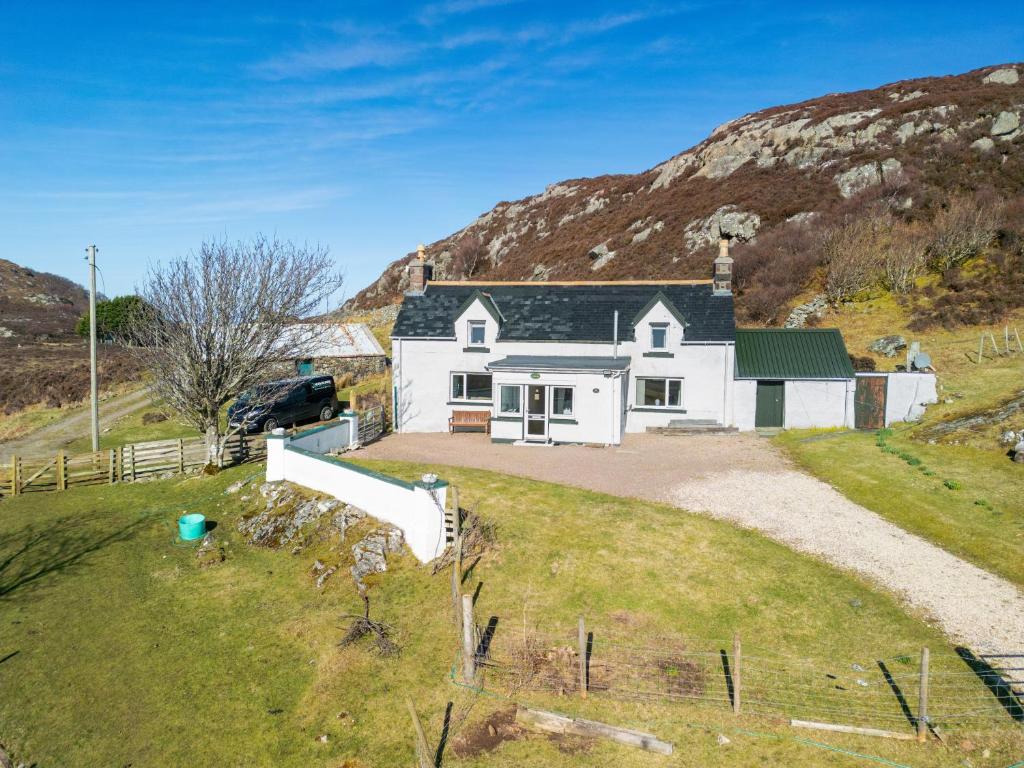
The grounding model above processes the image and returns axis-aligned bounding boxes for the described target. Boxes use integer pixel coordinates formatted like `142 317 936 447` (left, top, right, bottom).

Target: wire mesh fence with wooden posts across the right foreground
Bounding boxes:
473 618 1024 736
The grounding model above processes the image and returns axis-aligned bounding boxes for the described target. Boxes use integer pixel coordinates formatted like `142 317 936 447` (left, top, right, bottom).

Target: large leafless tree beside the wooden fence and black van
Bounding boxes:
136 236 341 465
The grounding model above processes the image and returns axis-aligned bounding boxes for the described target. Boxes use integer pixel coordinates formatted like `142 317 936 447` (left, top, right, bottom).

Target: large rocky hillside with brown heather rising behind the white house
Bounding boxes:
347 65 1024 323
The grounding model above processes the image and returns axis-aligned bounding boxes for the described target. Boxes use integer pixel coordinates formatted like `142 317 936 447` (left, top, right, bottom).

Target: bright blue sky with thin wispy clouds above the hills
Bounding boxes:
0 0 1024 303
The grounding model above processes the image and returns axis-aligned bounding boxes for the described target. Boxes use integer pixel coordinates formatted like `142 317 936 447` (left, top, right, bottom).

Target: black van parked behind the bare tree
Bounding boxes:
227 376 338 432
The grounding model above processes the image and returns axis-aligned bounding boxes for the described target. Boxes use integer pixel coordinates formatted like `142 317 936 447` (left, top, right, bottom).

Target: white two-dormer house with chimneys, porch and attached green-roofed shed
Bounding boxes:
392 244 934 444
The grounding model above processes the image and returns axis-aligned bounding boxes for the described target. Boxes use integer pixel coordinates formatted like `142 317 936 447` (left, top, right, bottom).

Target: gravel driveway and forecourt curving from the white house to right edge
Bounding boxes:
358 434 1024 651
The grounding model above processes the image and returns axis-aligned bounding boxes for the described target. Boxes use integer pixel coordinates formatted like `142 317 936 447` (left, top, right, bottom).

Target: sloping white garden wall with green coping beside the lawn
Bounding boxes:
266 425 447 562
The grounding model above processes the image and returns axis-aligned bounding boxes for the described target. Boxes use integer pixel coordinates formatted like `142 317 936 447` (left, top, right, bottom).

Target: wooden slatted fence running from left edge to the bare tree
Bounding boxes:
0 434 266 497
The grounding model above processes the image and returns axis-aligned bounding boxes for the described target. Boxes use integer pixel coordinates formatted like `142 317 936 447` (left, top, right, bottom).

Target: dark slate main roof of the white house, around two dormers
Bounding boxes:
391 281 735 343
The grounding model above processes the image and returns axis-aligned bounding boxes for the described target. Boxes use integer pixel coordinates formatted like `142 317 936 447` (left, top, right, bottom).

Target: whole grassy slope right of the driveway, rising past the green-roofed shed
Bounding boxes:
776 296 1024 586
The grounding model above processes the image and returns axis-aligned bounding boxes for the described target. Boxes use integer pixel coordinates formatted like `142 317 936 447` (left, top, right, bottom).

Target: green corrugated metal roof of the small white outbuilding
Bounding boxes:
736 328 854 379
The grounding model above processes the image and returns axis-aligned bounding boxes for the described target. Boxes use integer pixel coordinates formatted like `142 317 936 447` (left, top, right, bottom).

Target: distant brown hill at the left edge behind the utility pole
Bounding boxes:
0 259 89 343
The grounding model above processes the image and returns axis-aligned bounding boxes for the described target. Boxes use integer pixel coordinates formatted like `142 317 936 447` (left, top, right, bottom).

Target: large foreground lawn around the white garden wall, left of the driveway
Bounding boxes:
0 460 1024 768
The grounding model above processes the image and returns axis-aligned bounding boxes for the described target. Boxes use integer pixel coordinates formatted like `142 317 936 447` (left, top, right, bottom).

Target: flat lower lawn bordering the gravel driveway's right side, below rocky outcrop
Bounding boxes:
775 427 1024 587
